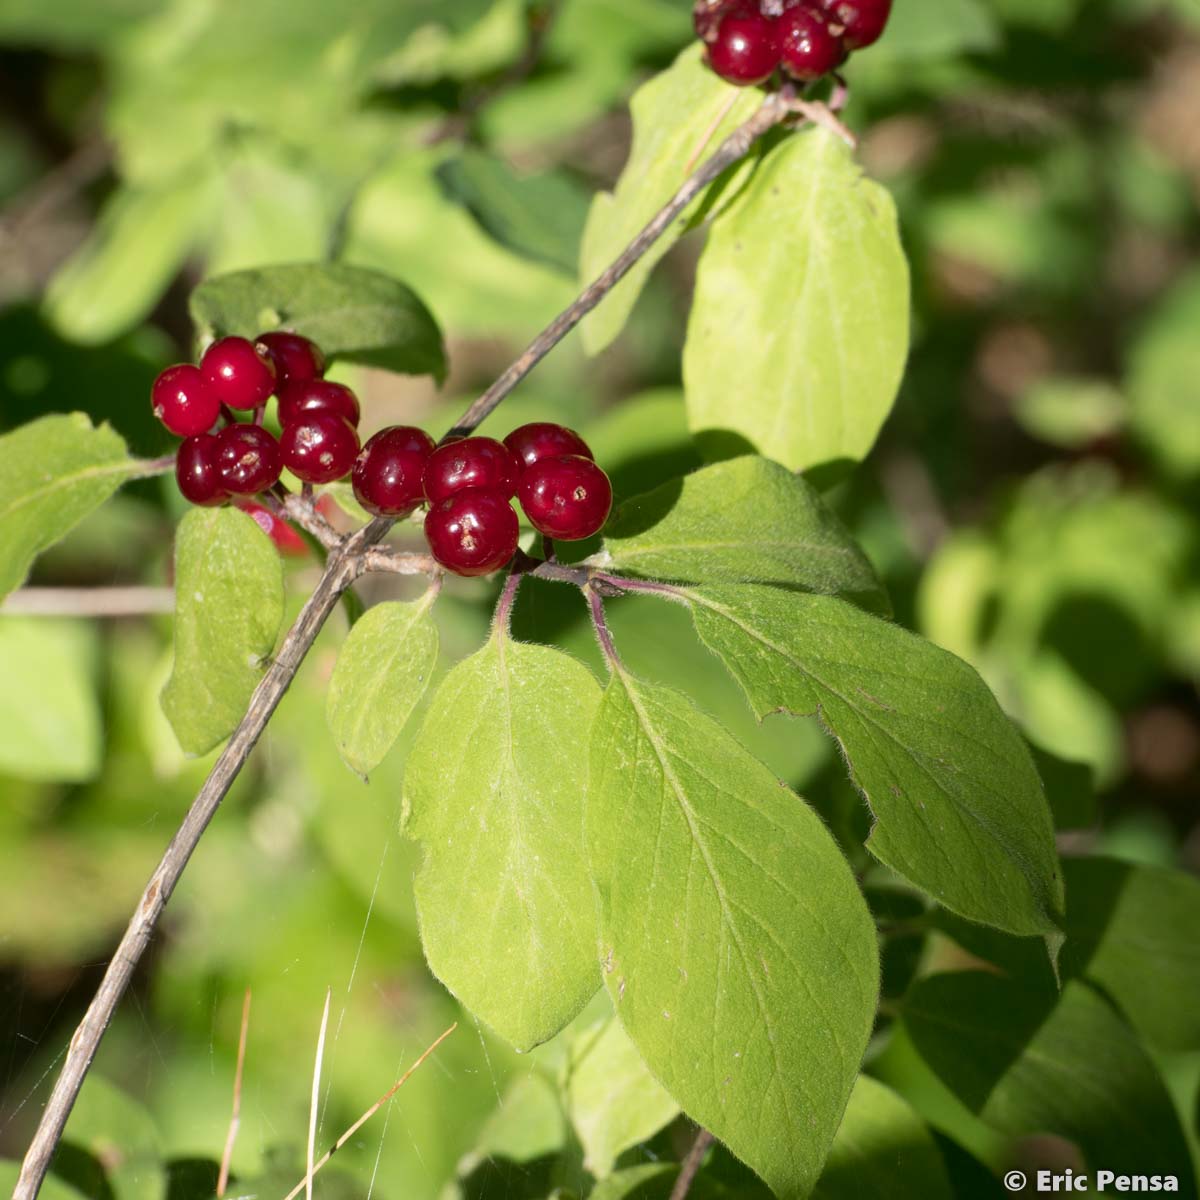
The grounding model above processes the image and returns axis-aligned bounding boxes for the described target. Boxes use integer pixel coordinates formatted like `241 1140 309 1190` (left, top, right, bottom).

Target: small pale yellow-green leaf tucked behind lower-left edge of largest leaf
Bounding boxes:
566 1018 679 1178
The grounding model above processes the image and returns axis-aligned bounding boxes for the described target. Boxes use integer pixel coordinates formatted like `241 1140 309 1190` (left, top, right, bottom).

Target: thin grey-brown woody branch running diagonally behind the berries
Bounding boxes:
13 88 794 1200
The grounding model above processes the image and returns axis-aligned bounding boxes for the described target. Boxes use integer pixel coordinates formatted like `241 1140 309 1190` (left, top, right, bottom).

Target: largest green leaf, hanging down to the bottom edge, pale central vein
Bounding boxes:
586 670 878 1198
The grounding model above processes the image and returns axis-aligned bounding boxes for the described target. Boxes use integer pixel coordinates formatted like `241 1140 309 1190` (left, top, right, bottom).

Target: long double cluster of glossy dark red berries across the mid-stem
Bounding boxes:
151 332 612 575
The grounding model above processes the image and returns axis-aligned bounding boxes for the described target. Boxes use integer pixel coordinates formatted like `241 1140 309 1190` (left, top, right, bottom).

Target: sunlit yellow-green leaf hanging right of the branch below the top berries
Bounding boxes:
683 128 908 470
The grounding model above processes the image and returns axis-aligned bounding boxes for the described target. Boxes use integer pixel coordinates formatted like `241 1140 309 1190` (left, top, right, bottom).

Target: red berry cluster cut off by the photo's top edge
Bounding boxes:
695 0 892 86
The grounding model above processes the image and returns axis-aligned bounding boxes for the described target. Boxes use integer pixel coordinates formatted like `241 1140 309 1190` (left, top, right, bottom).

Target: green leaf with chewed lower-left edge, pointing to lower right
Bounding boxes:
688 586 1063 935
